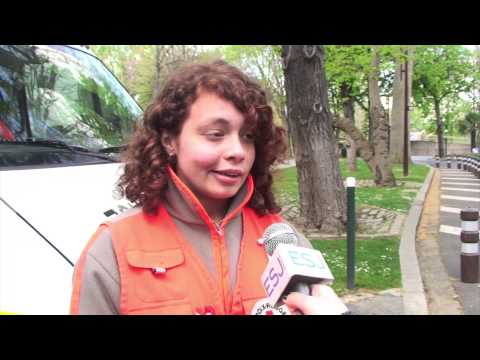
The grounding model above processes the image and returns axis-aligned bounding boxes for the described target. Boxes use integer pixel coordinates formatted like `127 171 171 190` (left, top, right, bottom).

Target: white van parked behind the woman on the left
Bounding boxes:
0 45 142 314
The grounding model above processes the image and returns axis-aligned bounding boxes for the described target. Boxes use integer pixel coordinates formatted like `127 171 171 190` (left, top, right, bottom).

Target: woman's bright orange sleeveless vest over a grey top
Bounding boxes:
72 168 282 315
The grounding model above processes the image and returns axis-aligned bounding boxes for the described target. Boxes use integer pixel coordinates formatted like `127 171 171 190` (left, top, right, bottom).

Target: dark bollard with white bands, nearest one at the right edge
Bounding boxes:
460 208 480 284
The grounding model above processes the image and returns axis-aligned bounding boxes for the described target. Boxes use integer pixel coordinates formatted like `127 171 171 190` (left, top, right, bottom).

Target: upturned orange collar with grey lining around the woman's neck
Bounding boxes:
165 165 254 228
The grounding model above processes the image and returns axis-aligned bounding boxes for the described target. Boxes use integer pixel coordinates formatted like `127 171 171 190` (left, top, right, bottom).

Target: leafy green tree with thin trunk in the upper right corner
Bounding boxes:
413 45 476 157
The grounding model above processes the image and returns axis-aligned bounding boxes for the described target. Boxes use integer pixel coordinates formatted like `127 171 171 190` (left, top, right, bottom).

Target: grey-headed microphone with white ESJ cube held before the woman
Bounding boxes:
261 223 334 307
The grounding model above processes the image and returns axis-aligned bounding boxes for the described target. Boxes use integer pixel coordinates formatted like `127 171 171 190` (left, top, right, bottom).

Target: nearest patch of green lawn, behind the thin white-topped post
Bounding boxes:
312 236 402 296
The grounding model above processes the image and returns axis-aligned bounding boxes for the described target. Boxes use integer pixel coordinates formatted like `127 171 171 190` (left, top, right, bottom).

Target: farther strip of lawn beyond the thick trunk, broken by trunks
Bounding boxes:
273 159 429 213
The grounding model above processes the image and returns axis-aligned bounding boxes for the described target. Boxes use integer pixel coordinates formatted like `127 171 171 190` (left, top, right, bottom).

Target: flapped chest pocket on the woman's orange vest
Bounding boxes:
126 249 191 304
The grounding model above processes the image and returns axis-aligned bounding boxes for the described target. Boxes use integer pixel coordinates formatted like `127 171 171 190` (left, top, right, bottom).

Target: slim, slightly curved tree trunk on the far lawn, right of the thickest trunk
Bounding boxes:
368 47 396 186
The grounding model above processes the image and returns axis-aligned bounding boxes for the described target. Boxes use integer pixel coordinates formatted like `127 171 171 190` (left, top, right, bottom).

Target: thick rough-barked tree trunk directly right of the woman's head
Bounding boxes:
282 45 346 233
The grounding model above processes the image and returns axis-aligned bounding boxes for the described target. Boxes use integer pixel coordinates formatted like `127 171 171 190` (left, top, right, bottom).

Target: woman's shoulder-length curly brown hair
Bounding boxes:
118 60 286 215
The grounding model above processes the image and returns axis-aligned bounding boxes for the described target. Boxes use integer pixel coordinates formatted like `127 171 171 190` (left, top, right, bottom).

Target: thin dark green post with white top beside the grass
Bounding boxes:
345 177 356 290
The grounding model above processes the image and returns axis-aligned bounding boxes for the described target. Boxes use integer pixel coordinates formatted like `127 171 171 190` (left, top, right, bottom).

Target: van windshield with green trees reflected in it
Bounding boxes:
0 45 142 151
